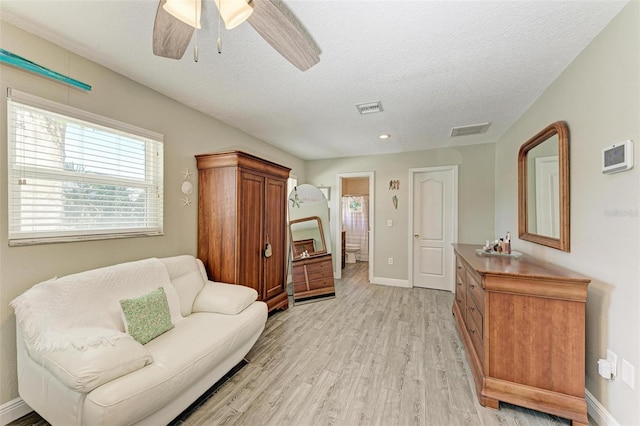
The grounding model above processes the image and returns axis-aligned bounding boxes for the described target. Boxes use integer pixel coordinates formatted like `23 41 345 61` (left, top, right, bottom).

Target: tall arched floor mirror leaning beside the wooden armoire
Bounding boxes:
289 184 336 303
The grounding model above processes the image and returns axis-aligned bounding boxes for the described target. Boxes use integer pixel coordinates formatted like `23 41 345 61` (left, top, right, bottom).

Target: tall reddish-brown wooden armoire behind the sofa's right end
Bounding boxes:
196 151 290 312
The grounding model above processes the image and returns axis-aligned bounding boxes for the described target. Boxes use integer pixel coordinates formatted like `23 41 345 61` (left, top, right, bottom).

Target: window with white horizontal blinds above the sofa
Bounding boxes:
7 90 163 245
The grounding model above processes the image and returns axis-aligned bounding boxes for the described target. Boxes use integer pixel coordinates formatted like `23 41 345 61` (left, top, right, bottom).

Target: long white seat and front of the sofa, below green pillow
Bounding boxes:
83 302 267 424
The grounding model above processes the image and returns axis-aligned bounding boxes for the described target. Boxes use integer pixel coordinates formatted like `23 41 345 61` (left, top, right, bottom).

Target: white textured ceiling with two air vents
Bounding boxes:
0 0 627 159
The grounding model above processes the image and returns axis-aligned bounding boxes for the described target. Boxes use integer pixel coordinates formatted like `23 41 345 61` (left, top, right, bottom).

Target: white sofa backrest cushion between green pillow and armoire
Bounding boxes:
160 255 206 317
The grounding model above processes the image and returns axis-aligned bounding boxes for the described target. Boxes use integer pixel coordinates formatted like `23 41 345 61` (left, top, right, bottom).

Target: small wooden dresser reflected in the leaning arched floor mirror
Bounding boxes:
293 253 336 301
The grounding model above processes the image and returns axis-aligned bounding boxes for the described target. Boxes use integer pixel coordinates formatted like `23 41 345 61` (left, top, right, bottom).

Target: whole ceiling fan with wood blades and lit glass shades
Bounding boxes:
153 0 320 71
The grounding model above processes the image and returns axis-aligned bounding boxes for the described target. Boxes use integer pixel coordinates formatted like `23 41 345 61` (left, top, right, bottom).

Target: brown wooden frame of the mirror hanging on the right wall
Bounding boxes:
518 121 571 252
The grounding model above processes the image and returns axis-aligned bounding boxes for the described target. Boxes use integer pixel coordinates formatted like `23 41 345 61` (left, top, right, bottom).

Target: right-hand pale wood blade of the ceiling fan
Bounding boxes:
248 0 320 71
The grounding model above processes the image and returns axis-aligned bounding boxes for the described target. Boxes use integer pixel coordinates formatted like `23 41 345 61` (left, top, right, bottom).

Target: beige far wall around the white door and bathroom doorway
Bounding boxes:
306 144 496 281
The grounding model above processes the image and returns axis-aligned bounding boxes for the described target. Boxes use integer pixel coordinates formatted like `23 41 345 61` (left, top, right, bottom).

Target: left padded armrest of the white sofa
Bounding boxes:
36 335 153 393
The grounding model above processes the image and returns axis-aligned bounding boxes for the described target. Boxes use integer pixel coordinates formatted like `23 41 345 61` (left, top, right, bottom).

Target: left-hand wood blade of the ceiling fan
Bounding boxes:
153 0 194 59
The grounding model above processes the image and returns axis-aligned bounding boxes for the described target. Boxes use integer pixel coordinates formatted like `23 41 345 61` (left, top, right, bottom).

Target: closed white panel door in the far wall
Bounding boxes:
412 166 458 291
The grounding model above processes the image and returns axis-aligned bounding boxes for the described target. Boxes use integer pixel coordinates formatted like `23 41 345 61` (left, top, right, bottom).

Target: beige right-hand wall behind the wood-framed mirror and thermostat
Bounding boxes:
495 1 640 425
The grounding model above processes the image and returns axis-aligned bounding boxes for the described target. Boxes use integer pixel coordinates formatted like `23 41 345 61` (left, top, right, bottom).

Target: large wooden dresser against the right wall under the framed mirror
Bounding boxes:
453 244 590 425
